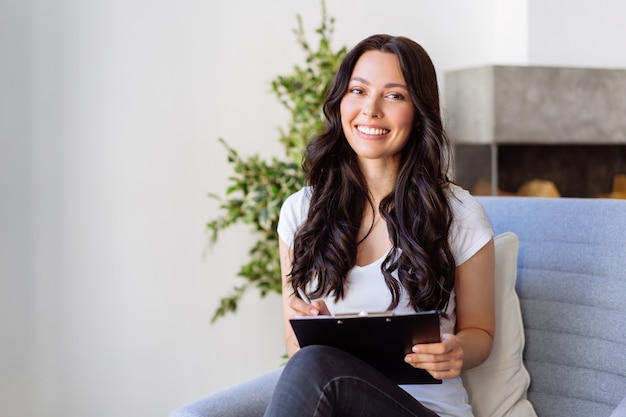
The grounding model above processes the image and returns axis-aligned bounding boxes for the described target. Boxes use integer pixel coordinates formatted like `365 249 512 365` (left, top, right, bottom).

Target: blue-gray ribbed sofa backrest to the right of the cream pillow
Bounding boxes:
480 197 626 417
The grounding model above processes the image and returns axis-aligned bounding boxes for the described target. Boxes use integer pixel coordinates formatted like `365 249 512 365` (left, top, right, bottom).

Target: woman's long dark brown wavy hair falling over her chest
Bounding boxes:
288 35 455 311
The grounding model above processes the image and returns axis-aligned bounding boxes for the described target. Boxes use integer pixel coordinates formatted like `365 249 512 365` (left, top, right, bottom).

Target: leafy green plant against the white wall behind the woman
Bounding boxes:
206 0 346 323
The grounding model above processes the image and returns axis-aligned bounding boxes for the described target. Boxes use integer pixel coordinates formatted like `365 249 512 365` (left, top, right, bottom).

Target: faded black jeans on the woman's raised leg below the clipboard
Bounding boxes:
265 346 437 417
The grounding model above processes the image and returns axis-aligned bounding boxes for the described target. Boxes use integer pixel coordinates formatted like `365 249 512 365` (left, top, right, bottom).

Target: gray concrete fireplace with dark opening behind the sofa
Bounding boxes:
444 66 626 197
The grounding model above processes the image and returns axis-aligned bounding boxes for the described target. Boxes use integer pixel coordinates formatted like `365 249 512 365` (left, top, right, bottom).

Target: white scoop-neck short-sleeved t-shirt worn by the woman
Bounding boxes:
278 184 493 417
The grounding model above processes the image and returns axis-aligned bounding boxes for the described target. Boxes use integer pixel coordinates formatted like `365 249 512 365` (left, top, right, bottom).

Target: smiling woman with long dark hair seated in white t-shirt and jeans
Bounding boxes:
169 35 494 417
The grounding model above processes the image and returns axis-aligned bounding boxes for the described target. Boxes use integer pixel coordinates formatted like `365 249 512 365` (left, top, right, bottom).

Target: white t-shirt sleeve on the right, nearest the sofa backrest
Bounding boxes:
449 187 493 266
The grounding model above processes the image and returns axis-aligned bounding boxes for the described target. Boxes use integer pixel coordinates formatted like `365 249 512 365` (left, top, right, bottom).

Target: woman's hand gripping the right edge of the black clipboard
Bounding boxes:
404 333 463 379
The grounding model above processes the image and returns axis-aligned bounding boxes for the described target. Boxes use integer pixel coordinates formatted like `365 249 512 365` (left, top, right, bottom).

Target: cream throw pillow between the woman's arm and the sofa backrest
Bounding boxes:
462 232 537 417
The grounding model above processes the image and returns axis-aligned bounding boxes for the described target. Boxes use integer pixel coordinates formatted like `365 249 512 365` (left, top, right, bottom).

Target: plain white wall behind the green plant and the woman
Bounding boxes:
0 0 626 417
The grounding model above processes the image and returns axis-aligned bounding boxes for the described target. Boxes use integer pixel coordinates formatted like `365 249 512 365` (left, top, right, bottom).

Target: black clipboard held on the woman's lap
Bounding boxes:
289 311 441 384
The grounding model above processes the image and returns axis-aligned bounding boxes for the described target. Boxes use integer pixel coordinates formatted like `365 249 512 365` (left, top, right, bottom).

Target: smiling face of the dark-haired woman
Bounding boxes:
340 51 415 161
